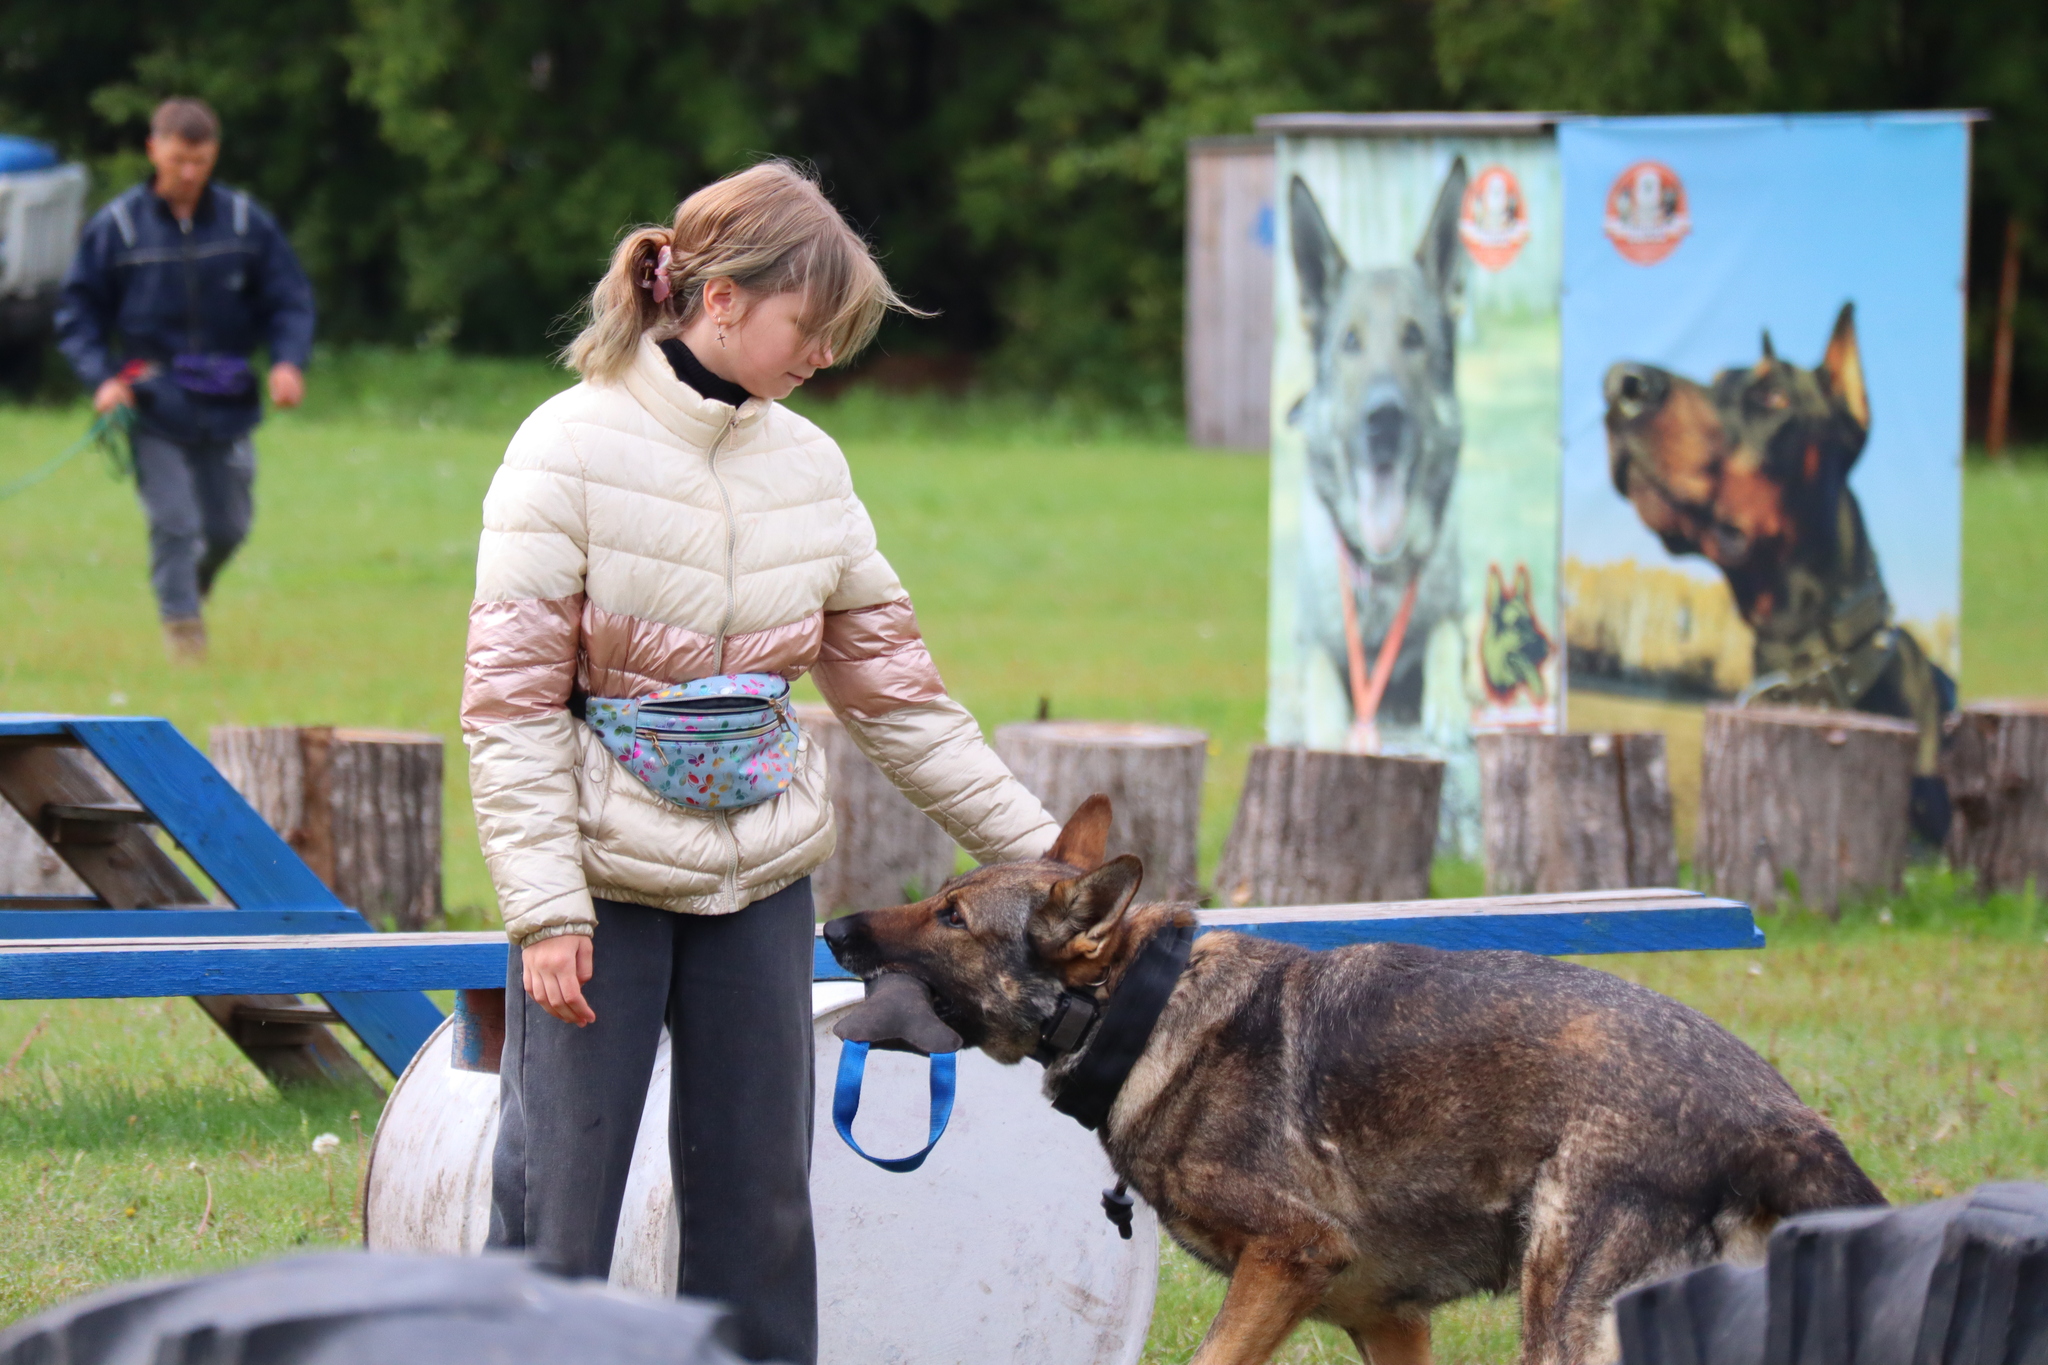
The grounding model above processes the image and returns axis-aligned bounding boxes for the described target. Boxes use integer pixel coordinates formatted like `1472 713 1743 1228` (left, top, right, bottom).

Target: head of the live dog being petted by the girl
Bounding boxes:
825 796 1153 1062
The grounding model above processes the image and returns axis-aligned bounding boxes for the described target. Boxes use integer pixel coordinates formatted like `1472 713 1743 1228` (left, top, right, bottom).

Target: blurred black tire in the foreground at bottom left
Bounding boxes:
0 1252 765 1365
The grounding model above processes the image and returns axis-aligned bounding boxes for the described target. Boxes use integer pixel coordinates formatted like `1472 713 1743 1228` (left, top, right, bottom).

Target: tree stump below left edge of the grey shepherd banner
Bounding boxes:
1217 747 1444 907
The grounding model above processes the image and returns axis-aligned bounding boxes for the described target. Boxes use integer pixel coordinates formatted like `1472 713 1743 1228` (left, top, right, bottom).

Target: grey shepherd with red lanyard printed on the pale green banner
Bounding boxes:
1288 158 1466 749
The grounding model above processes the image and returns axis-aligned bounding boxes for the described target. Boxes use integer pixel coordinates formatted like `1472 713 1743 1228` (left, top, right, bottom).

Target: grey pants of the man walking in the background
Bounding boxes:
133 430 256 620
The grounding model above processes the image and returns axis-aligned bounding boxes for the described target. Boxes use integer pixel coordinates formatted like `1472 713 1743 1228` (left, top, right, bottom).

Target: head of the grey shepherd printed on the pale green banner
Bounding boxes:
1288 158 1466 573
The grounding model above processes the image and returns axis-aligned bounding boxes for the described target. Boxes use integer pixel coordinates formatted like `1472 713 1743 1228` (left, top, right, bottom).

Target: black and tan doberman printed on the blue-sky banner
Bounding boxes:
1606 303 1956 843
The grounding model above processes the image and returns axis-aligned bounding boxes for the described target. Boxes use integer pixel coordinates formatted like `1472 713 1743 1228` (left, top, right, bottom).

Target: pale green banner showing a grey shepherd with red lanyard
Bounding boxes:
1266 135 1563 853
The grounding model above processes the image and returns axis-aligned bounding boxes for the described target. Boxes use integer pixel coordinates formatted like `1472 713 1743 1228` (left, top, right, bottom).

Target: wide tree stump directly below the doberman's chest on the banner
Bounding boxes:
1698 706 1917 915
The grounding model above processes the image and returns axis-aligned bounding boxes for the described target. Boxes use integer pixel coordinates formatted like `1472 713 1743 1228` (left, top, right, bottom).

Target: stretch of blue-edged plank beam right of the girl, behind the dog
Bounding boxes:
811 888 1763 980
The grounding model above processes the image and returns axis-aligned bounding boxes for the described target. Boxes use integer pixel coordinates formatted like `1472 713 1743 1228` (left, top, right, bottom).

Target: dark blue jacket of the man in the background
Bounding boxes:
55 182 313 442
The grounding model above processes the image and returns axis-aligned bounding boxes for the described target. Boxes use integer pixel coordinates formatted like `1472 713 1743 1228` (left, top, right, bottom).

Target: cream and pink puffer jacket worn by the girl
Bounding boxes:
463 340 1057 945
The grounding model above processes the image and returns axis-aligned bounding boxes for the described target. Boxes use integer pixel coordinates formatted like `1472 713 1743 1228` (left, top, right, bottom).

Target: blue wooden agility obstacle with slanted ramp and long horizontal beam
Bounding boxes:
0 714 1763 1078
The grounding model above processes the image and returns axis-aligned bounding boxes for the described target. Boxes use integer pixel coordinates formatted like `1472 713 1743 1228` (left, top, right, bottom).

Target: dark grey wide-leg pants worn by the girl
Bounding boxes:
489 878 817 1365
